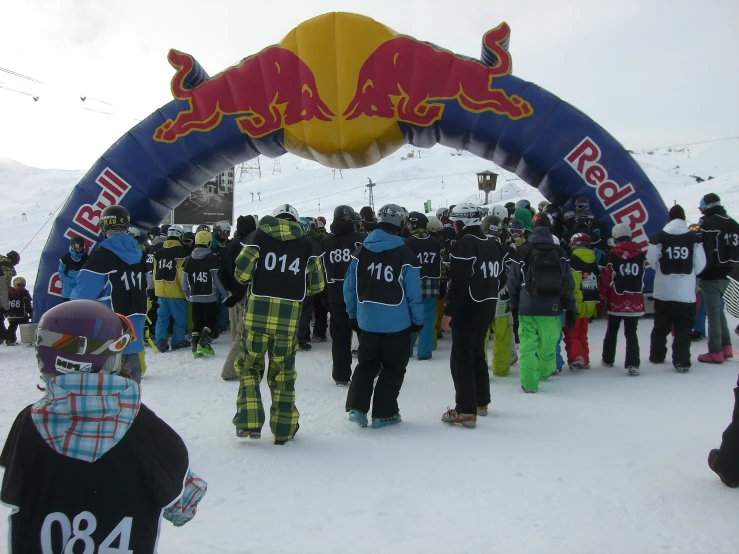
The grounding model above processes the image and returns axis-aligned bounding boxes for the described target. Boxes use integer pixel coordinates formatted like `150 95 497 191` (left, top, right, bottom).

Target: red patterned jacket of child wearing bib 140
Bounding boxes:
598 241 647 316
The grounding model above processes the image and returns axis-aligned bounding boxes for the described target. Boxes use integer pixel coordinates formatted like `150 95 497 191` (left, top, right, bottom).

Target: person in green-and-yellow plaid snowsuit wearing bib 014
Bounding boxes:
233 204 324 444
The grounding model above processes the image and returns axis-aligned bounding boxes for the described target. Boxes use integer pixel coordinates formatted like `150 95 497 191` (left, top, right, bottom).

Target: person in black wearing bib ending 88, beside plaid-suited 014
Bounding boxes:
321 205 366 386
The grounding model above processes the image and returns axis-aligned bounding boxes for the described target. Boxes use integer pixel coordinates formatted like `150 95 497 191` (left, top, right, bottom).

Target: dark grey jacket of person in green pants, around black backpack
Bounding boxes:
508 227 577 316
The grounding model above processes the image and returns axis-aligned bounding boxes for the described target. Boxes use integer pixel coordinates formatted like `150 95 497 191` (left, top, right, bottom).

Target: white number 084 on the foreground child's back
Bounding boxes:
41 512 133 554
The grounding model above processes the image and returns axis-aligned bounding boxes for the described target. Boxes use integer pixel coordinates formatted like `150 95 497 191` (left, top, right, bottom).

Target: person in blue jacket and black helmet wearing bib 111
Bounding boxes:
70 205 150 383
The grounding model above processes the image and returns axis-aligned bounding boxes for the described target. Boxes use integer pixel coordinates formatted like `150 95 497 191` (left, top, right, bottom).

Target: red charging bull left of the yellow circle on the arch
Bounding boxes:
153 46 335 143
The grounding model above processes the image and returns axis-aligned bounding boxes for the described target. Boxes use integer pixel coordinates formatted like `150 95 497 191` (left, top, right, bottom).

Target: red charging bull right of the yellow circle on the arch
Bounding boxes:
342 22 534 127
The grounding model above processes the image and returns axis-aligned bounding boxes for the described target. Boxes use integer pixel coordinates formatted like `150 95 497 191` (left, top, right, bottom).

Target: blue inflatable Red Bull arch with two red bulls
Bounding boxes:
34 13 667 321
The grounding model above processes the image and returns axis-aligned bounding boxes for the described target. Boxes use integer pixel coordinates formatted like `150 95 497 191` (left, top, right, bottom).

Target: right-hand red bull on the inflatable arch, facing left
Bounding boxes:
343 23 534 127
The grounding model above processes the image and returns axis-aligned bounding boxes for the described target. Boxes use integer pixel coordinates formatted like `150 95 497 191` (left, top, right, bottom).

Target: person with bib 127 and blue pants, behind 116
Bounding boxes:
405 212 446 360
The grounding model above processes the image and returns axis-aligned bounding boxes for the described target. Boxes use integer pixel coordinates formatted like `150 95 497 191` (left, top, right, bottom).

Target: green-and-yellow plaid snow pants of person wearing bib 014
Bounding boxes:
233 330 300 440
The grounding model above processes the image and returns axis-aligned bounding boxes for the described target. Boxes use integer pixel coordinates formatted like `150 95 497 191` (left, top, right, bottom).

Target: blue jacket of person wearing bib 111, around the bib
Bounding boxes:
70 233 146 354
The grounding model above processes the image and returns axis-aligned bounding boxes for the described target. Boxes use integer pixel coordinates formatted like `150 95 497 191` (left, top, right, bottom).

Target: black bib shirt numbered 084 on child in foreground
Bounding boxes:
0 404 189 554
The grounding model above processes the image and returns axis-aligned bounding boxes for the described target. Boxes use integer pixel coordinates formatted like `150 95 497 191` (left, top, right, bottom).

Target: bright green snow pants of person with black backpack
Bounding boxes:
518 315 562 392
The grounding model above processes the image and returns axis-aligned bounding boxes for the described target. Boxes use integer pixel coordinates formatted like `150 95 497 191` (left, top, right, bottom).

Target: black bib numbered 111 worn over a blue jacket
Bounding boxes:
83 247 147 316
